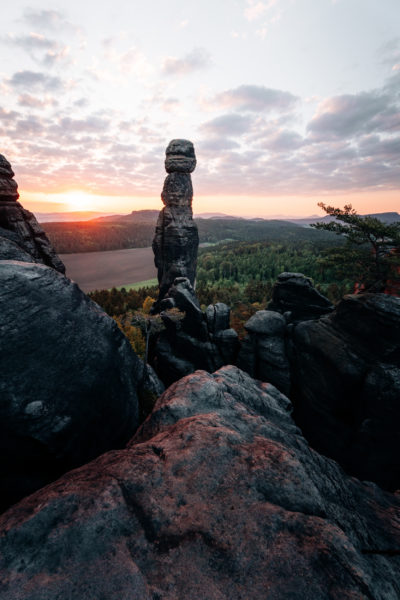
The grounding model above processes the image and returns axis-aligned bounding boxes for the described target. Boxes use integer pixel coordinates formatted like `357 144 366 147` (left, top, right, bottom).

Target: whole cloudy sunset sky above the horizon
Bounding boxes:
0 0 400 217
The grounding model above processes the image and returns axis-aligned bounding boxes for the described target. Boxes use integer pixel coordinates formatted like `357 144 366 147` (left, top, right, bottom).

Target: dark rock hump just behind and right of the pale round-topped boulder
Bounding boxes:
268 273 334 322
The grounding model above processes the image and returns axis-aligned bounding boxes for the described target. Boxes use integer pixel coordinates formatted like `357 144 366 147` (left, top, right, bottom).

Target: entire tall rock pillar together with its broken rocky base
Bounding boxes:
152 140 239 385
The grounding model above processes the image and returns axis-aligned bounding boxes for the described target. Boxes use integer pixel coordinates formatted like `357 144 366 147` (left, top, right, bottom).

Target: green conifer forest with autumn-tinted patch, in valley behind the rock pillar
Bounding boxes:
89 230 354 346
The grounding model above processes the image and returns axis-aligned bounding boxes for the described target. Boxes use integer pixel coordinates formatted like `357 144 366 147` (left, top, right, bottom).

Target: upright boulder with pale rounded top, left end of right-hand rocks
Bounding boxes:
237 310 290 394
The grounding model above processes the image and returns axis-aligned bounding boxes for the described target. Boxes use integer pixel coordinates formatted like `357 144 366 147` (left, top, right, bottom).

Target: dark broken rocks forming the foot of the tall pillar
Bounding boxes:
154 277 239 386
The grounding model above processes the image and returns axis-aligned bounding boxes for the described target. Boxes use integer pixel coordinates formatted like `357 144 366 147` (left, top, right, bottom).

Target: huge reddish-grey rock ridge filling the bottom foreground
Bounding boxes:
0 367 400 600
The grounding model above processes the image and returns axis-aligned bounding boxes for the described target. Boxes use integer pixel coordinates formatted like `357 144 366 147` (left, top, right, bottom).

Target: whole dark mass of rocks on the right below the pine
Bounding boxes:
237 273 400 490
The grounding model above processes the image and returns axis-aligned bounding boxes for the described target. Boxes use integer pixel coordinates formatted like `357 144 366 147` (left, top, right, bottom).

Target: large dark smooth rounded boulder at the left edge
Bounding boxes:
0 261 142 510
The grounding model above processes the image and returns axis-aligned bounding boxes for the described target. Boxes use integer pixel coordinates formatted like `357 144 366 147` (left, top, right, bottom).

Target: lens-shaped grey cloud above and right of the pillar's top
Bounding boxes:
210 85 298 112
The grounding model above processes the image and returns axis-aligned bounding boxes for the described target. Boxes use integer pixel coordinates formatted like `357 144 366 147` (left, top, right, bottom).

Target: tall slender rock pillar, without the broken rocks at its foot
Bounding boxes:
153 140 199 312
